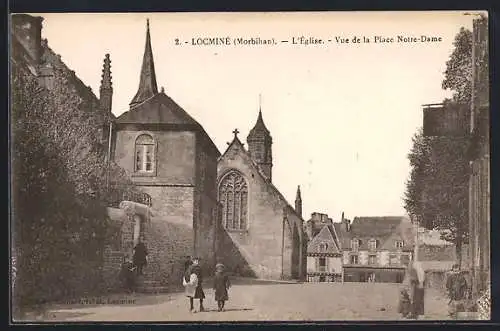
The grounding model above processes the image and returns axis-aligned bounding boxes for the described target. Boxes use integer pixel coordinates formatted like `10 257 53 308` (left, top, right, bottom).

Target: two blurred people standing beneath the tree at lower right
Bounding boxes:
399 261 468 319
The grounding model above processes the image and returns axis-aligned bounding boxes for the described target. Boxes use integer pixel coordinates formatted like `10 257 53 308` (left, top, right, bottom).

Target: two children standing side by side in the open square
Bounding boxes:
182 257 231 312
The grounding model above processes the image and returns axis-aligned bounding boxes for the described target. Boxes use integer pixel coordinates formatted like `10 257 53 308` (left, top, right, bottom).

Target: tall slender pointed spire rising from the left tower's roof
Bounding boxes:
130 19 158 107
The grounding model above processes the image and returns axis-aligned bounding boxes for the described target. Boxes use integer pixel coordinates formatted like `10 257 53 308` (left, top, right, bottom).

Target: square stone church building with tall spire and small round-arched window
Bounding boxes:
109 21 220 285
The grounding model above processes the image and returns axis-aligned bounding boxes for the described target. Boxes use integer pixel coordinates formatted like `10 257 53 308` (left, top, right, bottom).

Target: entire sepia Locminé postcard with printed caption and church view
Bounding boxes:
10 11 491 323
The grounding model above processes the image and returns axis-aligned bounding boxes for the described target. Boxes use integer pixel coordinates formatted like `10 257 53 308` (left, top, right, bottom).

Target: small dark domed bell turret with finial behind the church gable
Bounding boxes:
247 97 273 180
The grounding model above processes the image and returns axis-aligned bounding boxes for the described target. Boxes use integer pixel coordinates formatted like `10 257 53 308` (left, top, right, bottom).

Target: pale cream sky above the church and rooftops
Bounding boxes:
34 12 473 221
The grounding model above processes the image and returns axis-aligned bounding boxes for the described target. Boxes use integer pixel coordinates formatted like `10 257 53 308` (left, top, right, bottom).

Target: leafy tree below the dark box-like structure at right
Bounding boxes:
404 131 469 262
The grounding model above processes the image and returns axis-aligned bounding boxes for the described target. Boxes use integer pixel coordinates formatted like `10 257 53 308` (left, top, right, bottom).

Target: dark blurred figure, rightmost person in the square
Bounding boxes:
446 264 467 319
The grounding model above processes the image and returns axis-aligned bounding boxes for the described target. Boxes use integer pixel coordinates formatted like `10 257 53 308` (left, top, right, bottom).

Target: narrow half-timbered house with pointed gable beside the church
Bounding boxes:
307 213 343 282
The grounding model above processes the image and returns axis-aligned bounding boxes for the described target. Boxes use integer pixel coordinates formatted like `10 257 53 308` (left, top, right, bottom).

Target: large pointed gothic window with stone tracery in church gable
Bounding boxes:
219 171 248 231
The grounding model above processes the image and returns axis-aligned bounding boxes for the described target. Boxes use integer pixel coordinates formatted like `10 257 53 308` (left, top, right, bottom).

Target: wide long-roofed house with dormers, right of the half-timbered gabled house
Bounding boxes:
333 216 414 283
